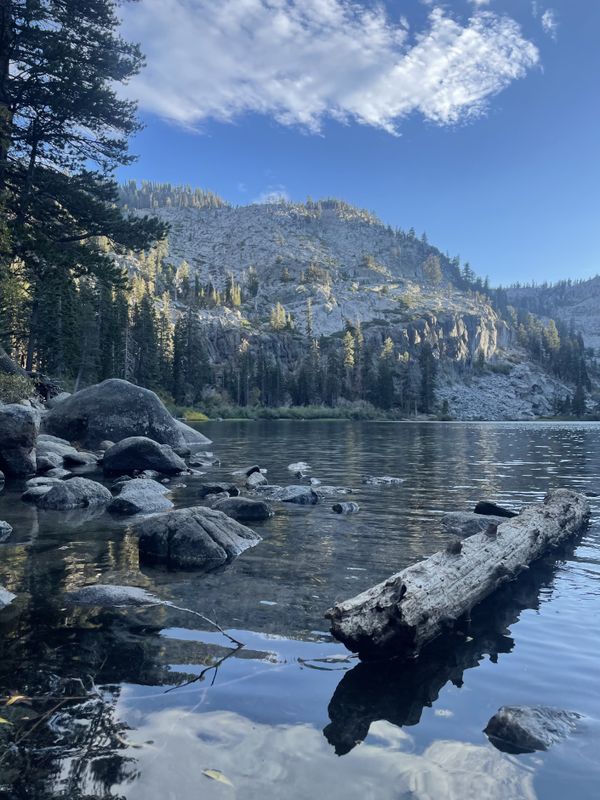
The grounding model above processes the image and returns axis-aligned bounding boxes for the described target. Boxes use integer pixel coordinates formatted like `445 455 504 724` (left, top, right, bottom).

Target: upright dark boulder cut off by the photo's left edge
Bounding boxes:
0 403 40 478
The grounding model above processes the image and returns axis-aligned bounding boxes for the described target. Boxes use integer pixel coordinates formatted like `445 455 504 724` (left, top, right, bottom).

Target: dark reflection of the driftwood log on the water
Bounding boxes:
323 543 576 756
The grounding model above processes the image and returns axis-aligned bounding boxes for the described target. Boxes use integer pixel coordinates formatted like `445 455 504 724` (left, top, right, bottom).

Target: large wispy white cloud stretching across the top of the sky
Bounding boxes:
123 0 539 132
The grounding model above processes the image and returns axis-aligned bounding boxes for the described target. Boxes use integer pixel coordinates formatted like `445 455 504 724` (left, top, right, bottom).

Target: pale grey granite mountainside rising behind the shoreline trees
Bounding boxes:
119 188 572 419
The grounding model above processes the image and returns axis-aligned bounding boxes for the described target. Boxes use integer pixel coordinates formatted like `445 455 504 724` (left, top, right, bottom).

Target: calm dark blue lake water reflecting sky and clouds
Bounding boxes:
0 422 600 800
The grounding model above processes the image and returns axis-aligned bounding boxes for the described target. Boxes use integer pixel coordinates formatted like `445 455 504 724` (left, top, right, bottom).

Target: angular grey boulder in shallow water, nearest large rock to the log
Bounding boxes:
135 506 261 570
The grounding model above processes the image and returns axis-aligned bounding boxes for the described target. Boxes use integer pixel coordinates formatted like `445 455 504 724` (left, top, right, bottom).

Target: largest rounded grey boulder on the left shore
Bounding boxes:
44 378 210 449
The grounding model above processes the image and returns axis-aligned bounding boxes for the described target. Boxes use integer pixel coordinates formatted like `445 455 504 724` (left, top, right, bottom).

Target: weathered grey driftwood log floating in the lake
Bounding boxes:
325 489 590 659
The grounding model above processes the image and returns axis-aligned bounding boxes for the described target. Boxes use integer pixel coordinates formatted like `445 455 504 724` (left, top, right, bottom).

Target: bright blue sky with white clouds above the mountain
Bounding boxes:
115 0 600 284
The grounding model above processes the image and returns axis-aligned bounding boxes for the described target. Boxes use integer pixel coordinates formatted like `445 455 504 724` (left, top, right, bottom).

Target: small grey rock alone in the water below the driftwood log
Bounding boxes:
484 706 581 753
